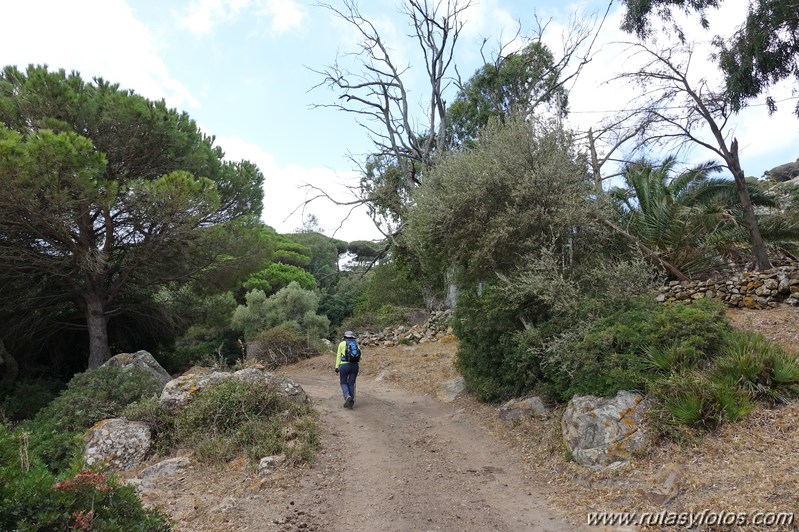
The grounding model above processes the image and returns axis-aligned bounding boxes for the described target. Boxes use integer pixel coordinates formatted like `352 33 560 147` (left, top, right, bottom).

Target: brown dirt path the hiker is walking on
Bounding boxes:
285 372 573 531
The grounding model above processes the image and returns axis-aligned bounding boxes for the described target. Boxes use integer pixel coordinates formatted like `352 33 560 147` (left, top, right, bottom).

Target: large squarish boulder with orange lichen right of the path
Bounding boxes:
561 391 647 468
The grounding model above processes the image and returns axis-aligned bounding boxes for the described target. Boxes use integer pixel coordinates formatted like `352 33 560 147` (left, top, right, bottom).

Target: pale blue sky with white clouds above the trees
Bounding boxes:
0 0 799 241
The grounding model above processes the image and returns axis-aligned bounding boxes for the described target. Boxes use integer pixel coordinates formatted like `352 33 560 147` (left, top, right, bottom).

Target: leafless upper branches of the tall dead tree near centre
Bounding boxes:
315 0 471 185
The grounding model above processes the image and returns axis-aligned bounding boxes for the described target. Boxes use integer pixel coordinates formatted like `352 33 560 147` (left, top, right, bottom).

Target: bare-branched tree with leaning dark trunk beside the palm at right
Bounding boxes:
619 42 771 270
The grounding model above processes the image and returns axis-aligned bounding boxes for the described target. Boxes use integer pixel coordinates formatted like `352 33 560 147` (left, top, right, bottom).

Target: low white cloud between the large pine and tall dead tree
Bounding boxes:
217 137 381 240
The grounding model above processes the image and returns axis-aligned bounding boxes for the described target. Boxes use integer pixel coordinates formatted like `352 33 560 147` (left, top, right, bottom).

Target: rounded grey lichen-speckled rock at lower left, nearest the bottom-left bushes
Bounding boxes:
83 418 152 469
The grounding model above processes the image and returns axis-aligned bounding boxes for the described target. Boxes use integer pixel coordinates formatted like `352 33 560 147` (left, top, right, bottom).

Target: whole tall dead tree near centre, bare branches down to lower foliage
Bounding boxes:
306 0 472 250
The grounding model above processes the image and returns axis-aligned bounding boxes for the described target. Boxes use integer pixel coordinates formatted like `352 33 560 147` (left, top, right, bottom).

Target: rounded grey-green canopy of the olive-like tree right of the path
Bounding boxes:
408 116 591 281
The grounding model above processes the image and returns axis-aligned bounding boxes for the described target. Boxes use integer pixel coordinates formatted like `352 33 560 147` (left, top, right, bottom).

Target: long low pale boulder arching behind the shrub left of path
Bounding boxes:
158 368 309 409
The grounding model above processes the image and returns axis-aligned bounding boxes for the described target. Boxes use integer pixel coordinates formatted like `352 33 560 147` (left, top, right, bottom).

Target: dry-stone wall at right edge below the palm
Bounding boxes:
657 265 799 309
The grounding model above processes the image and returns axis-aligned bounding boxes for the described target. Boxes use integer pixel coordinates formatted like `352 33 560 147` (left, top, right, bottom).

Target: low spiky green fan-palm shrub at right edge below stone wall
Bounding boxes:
713 331 799 402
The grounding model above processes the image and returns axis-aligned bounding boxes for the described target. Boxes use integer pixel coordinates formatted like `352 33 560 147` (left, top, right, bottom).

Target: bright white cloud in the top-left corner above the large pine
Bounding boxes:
0 0 199 108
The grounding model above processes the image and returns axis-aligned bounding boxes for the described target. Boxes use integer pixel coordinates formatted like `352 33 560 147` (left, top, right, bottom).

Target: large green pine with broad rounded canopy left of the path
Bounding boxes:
0 66 263 367
